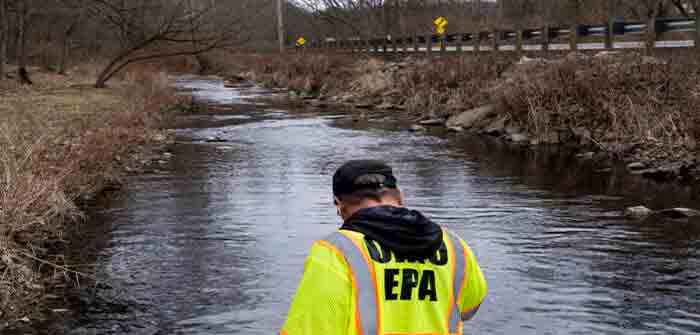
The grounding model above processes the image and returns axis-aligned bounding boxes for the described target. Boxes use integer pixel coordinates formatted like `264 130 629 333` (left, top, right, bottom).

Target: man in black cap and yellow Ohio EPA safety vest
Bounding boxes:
281 160 486 335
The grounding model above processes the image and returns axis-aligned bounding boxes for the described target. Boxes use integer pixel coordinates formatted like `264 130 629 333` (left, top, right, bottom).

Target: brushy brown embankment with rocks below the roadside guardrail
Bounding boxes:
208 53 700 178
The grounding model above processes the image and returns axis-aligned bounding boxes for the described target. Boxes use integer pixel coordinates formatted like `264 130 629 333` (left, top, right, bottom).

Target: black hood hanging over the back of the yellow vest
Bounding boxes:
340 206 442 257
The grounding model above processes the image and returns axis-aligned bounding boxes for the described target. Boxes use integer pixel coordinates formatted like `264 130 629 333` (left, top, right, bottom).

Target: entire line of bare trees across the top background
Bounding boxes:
0 0 700 87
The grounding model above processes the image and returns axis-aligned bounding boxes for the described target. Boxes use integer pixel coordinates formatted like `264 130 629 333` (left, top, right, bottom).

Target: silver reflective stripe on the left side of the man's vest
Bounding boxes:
326 232 379 335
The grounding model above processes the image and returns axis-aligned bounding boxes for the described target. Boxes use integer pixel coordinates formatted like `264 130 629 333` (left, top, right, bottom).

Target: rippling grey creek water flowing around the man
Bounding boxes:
47 77 700 335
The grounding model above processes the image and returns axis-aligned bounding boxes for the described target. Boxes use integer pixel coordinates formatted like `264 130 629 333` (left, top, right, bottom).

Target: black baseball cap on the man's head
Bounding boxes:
333 159 396 196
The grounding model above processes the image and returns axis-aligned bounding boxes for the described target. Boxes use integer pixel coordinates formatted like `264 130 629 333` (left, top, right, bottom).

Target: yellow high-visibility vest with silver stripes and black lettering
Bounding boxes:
280 229 487 335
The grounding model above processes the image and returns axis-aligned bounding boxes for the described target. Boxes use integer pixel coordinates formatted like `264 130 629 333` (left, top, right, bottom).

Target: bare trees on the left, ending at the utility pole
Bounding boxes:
0 0 275 87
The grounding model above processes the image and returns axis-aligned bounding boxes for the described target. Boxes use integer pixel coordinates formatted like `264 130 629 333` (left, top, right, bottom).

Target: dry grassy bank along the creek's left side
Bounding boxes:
0 64 180 326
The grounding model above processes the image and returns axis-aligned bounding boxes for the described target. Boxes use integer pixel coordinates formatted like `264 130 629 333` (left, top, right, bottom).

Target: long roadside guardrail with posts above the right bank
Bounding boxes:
308 18 700 53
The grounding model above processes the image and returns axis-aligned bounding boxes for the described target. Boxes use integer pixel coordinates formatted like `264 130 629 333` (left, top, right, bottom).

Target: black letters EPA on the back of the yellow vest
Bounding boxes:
384 268 437 301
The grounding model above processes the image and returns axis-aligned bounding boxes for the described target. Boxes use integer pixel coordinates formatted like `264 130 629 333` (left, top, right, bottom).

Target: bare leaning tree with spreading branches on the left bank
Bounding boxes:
89 0 267 87
